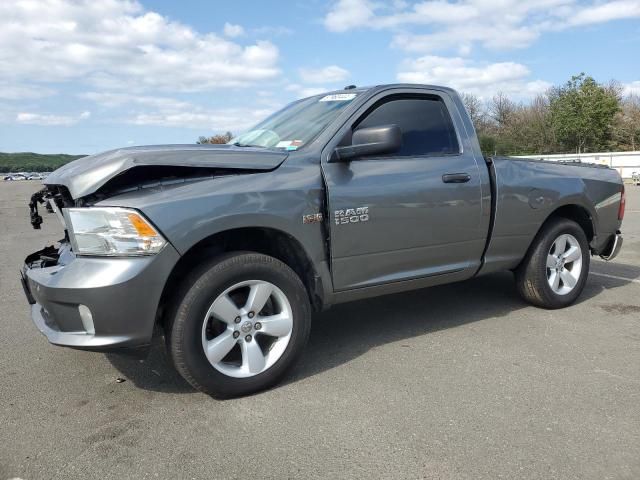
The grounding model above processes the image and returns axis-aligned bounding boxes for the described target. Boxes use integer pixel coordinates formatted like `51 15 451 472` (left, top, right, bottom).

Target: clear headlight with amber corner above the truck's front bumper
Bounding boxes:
64 207 167 257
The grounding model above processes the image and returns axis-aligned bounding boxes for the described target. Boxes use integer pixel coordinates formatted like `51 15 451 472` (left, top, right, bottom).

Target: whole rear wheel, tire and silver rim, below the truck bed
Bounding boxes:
515 218 591 309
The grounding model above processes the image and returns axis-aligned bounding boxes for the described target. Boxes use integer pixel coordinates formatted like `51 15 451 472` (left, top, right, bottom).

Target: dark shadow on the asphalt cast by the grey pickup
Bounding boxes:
102 264 640 393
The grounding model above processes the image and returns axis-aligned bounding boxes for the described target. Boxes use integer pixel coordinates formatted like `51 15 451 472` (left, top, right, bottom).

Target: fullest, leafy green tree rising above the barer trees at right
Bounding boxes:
549 73 620 153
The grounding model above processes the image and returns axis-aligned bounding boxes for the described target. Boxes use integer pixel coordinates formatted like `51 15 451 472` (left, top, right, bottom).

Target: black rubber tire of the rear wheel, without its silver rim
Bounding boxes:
515 218 591 309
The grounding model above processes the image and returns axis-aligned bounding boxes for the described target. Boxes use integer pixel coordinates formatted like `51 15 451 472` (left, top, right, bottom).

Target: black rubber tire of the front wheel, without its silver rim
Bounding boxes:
165 252 311 398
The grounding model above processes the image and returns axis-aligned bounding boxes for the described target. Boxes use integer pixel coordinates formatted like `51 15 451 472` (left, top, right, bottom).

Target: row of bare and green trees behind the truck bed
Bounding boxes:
462 73 640 155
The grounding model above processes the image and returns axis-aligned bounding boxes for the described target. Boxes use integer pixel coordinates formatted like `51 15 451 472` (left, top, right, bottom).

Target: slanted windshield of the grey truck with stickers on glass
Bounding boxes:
229 93 357 150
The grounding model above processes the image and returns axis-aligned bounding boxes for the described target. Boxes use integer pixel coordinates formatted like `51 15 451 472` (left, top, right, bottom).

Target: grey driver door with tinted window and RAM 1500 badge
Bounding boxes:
322 90 489 291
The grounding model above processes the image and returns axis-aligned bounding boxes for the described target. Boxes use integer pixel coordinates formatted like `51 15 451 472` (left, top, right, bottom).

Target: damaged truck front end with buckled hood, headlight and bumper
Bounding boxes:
21 142 287 350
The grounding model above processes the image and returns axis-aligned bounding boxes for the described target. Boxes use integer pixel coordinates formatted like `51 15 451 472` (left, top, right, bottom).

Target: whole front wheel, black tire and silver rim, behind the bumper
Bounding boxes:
166 253 311 398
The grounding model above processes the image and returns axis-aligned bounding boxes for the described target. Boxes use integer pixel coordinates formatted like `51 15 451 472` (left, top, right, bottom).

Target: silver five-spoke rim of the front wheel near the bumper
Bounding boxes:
202 280 293 378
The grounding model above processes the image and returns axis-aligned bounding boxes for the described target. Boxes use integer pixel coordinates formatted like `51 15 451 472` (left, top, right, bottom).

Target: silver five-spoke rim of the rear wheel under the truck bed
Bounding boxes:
547 233 582 295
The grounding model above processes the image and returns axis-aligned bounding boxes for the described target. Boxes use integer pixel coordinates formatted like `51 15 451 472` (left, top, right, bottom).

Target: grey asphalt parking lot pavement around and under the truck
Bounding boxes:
0 182 640 480
